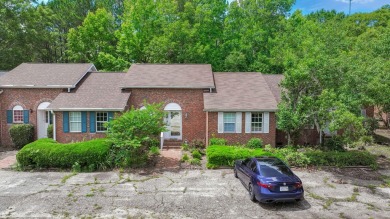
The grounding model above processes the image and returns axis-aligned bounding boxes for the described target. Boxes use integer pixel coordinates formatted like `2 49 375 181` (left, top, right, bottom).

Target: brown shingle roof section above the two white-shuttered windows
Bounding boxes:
203 72 277 112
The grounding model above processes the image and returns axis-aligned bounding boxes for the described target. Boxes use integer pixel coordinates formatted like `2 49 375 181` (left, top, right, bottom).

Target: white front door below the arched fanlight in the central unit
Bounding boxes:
164 111 182 140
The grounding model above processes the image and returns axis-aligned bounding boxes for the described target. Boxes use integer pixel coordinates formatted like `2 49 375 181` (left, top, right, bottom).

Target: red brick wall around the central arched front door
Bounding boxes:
130 89 206 142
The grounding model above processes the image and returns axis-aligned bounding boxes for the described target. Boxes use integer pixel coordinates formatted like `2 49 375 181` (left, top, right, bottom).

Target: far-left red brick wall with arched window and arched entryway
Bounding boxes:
0 88 62 147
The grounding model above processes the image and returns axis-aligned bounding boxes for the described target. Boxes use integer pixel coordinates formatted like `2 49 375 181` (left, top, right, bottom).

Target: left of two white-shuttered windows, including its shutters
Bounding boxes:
218 112 242 133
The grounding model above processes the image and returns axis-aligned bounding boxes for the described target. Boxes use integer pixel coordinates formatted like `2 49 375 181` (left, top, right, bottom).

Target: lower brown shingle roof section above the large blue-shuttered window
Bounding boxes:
47 72 130 111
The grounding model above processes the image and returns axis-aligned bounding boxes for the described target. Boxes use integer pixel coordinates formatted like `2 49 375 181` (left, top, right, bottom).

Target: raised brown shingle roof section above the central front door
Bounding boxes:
121 64 215 89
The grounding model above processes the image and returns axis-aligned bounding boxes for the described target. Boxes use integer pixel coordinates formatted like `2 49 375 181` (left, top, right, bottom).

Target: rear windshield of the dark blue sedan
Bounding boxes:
257 159 294 177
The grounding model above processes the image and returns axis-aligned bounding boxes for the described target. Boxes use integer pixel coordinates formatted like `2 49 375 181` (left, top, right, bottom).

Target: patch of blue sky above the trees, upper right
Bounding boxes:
293 0 390 14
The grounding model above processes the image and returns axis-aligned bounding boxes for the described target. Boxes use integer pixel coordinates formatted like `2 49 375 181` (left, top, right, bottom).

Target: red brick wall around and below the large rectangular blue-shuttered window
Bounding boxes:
55 112 106 143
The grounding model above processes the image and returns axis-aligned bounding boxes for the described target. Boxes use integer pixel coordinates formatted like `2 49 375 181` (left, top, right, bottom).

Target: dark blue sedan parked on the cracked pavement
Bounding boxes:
234 157 304 203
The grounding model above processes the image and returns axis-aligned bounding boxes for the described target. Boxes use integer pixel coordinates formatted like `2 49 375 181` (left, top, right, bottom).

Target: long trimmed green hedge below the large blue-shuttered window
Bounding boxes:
16 138 111 169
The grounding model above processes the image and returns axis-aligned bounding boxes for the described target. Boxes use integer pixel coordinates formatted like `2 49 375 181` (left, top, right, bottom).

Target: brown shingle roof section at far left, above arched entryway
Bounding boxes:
0 63 96 88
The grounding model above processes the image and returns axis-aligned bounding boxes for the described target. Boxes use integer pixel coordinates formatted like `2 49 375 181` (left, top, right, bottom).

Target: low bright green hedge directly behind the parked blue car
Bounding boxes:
206 145 273 168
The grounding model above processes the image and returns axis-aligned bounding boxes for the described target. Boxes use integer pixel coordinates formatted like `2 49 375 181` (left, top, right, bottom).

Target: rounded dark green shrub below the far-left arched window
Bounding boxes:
9 124 34 149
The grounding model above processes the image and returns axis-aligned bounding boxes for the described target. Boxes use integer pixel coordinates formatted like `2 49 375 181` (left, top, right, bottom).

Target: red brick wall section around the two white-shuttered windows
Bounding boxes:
209 112 276 146
